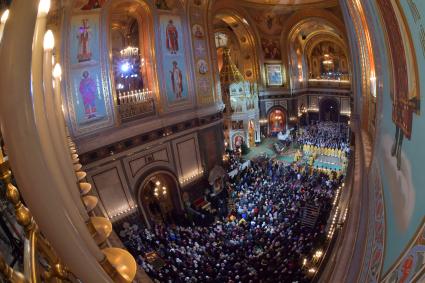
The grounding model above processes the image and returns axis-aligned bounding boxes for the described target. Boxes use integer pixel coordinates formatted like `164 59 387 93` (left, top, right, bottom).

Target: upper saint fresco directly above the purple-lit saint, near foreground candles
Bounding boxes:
69 14 100 65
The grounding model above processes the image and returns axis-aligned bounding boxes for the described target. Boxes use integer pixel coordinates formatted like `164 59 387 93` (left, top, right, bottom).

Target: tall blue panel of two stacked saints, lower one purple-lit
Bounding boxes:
66 12 114 136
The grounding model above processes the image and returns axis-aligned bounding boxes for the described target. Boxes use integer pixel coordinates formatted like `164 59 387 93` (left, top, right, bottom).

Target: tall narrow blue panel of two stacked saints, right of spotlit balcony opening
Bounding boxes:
160 15 188 103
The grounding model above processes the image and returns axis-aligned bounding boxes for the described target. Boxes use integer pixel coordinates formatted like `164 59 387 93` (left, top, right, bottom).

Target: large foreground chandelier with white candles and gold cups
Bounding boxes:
0 0 137 283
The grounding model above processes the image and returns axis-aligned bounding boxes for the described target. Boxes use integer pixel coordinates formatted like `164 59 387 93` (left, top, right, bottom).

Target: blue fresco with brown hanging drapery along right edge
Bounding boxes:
377 0 425 276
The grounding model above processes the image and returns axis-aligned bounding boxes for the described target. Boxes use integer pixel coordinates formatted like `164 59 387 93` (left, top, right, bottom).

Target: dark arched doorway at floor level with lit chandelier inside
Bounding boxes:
138 171 183 225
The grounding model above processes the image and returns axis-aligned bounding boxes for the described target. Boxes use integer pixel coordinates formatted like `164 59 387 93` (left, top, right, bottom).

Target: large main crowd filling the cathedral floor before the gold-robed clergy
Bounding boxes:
118 158 343 282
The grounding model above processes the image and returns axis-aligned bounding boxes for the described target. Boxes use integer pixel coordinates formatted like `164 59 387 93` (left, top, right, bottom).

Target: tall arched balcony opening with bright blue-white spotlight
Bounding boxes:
109 1 155 122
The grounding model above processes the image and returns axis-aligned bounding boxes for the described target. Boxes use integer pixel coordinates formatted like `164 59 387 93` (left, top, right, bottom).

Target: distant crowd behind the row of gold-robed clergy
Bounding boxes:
297 122 350 153
